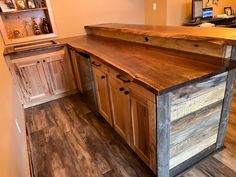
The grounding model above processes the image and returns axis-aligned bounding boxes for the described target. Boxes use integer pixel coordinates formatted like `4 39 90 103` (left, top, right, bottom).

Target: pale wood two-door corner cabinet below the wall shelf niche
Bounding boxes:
6 47 77 107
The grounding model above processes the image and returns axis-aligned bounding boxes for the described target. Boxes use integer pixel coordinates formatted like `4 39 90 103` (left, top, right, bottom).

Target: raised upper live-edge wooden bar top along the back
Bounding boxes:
85 23 236 45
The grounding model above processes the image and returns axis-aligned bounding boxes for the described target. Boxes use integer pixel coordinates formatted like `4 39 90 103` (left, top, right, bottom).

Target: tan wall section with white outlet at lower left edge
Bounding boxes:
0 39 28 177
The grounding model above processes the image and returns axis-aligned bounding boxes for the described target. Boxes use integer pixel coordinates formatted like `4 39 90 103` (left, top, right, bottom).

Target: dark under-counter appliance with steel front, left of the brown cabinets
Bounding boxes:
76 52 99 115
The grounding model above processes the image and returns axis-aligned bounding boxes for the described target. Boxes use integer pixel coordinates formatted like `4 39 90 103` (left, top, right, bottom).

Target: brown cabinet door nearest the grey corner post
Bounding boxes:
130 89 156 172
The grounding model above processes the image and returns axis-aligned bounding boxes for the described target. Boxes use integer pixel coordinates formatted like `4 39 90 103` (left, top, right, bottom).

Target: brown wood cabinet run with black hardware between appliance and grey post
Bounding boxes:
92 60 156 173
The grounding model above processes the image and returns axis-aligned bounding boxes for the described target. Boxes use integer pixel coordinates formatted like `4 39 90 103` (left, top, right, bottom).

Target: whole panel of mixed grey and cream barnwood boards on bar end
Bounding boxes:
169 72 228 169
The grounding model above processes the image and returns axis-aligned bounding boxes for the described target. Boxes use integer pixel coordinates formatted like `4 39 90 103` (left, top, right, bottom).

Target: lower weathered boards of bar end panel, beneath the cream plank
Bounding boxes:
170 101 222 169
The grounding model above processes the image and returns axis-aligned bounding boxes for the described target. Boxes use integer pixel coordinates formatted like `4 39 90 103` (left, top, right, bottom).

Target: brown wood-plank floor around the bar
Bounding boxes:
26 92 236 177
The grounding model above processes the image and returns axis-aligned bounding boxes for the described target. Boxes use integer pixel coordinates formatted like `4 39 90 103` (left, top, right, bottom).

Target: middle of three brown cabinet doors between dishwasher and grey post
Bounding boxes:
109 77 132 144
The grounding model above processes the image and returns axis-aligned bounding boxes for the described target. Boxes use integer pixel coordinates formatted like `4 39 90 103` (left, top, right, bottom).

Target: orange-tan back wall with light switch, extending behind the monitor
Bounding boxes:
145 0 236 26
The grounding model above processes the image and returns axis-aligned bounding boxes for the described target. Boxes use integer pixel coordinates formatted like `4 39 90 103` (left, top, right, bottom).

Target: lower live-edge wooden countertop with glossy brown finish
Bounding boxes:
55 35 227 94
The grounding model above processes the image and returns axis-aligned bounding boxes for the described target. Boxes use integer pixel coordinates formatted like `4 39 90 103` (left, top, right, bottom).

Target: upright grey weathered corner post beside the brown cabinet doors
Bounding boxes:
157 93 171 177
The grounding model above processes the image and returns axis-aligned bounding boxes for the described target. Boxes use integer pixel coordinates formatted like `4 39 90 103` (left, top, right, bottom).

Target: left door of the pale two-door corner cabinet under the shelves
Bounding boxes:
13 59 50 102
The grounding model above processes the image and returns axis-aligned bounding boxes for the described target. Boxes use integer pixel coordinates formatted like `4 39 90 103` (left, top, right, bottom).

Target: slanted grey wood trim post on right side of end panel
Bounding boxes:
216 69 236 149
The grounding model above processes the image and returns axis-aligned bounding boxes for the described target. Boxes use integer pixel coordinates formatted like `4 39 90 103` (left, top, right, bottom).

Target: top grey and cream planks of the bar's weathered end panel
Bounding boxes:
170 72 228 121
